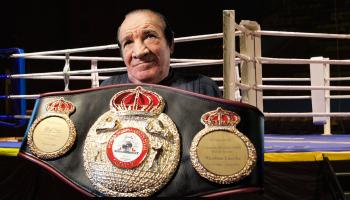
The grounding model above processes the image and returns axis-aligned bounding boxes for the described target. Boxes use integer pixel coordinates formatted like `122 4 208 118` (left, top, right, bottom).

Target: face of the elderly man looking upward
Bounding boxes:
118 12 171 83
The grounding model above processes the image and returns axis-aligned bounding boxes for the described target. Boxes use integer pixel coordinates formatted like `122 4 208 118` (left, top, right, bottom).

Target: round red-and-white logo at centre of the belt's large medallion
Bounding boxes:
107 128 148 169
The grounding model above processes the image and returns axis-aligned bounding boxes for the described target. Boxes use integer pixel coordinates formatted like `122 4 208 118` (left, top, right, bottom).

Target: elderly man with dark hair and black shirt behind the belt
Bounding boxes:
101 9 221 97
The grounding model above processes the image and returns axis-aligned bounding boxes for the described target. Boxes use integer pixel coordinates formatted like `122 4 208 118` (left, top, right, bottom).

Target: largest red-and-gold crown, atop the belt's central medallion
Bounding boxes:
111 86 164 114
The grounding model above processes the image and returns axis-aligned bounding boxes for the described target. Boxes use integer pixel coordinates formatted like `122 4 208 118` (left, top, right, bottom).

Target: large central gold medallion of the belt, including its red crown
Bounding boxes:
83 86 180 197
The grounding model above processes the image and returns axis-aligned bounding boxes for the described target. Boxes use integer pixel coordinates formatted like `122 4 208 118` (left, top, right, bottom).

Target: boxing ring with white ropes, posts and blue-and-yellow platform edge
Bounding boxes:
0 11 350 198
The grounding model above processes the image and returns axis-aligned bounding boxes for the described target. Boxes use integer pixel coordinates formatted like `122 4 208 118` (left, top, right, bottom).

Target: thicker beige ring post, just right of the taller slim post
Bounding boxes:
239 20 264 111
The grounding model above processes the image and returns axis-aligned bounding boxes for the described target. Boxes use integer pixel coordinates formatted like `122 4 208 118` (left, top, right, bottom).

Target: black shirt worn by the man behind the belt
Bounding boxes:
101 68 222 97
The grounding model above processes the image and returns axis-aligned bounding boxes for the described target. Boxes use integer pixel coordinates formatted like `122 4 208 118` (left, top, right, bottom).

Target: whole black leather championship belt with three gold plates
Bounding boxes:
18 84 264 197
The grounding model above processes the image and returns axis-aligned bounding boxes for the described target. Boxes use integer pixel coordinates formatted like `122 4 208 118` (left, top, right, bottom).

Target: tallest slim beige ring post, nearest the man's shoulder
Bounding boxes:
223 10 238 101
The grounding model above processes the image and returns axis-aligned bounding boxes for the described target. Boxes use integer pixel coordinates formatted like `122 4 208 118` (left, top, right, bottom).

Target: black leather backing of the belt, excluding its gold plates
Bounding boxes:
19 84 264 197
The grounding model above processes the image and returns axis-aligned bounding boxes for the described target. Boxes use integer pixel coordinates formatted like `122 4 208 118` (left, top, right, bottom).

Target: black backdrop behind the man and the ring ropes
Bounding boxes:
0 0 350 136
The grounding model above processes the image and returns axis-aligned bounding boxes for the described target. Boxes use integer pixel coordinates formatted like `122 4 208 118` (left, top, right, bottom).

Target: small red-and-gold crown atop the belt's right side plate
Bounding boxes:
201 107 240 126
